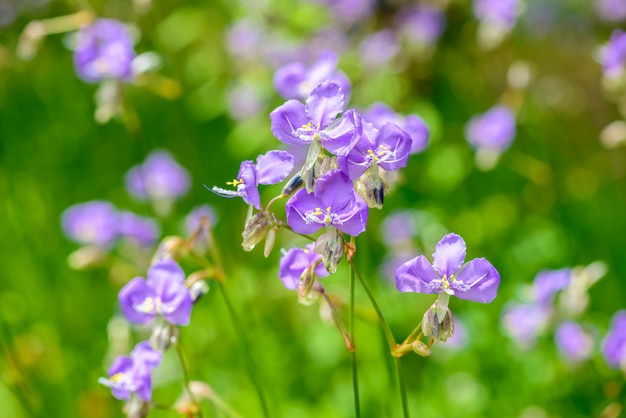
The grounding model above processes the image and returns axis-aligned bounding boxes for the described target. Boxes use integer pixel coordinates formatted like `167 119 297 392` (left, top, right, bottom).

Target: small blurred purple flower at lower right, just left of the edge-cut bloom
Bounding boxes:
501 303 552 350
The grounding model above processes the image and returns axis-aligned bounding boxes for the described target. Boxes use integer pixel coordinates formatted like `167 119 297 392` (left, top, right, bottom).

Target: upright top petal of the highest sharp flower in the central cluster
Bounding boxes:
304 81 345 128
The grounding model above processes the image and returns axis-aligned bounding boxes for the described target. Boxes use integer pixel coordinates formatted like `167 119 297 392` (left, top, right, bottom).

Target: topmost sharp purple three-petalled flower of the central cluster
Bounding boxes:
270 81 360 155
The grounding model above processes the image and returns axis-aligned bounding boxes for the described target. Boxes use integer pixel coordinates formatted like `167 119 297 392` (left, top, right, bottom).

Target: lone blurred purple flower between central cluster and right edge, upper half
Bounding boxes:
465 106 515 152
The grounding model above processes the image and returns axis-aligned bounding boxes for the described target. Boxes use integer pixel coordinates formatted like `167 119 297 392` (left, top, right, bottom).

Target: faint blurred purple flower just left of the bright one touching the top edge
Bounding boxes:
396 5 446 47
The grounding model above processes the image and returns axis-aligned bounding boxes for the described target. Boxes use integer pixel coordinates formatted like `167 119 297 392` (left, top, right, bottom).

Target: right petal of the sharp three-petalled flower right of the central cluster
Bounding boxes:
450 258 500 303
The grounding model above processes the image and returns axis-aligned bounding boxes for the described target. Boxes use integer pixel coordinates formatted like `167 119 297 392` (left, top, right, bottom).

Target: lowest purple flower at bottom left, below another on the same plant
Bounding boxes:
98 341 163 401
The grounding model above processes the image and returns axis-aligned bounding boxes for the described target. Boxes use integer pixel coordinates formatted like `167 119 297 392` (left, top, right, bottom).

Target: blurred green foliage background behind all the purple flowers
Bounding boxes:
0 0 626 418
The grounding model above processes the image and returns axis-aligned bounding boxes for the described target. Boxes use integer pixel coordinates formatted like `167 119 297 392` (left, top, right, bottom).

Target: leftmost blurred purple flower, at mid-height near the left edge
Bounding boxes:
61 200 119 248
